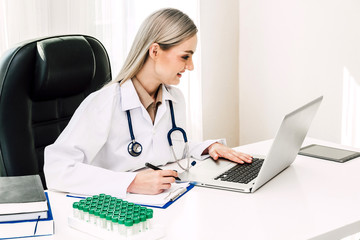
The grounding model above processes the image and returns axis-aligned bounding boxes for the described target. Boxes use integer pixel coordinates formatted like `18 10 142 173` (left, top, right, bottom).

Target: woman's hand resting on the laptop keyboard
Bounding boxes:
208 142 252 164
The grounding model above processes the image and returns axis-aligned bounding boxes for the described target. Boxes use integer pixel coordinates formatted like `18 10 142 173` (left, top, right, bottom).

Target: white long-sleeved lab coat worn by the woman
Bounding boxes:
44 80 223 198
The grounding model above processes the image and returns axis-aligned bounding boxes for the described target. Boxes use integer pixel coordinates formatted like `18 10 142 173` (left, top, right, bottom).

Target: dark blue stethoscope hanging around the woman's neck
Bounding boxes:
126 100 196 171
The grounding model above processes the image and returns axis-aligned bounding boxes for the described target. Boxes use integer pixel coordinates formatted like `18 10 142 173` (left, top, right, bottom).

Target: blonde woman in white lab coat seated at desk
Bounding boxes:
44 9 252 197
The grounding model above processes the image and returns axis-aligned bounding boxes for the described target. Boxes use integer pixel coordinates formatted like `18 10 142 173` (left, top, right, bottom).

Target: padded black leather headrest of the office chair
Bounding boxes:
32 36 96 100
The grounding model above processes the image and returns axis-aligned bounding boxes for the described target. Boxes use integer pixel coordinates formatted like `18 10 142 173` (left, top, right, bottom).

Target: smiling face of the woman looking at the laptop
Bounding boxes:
155 35 197 85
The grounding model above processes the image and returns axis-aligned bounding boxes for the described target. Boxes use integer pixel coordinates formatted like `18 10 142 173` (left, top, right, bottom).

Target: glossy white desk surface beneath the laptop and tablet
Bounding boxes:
43 139 360 240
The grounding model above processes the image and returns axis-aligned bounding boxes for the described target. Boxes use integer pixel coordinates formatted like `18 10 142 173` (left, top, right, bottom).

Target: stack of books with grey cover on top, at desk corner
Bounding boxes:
0 175 54 239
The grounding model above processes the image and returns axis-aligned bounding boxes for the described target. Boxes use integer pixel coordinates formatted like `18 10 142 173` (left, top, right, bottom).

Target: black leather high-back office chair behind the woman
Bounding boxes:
0 35 111 189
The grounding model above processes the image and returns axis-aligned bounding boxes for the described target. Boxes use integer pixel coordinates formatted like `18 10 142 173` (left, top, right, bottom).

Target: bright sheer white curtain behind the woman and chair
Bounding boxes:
0 0 202 140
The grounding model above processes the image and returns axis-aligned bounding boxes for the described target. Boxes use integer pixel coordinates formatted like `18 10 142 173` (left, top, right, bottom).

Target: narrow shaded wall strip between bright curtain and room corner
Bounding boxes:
199 0 239 147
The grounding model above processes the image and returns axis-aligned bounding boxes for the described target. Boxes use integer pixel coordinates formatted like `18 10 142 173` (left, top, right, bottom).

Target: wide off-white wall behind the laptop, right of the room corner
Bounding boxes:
239 0 360 145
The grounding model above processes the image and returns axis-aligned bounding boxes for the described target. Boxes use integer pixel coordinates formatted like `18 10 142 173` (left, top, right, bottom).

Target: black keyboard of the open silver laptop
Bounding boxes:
214 158 264 184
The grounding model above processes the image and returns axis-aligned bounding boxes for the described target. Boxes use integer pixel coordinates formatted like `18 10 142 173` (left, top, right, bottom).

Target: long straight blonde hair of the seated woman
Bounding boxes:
111 8 198 84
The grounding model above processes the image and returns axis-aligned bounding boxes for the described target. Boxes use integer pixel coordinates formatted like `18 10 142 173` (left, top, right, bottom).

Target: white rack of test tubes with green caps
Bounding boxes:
68 194 165 240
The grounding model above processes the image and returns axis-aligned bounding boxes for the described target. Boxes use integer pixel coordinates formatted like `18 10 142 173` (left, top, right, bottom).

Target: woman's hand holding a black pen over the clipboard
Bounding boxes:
127 169 178 194
